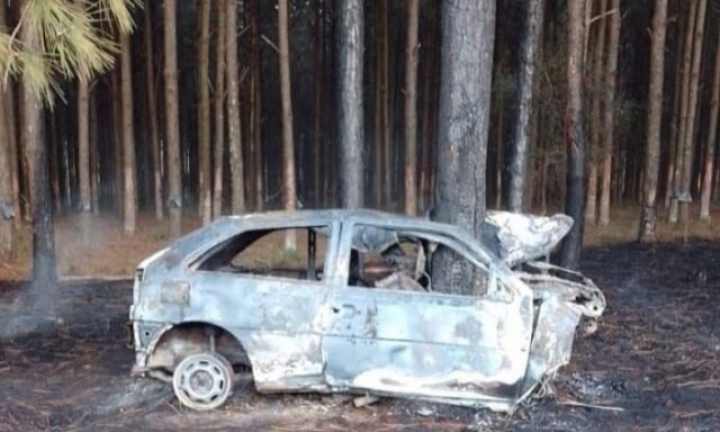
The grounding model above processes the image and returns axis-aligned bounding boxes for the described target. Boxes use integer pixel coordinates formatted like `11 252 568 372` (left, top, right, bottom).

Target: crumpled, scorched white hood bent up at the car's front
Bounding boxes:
482 211 574 267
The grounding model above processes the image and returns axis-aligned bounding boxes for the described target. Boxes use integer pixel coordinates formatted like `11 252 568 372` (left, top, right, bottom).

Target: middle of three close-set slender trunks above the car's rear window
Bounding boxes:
213 0 230 217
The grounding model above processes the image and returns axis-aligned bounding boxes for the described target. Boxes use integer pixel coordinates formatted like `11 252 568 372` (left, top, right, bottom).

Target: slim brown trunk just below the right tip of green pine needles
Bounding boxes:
120 33 137 235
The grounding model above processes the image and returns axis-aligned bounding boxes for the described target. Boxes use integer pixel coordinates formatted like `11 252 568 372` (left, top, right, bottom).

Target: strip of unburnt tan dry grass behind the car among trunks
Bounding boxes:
0 202 720 280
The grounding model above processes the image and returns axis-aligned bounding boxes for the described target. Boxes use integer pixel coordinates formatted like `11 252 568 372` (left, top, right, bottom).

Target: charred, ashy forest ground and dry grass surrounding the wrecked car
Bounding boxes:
0 205 720 432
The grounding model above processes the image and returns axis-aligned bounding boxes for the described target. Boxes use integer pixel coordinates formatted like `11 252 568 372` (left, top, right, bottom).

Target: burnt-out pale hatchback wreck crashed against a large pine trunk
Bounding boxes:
130 210 605 411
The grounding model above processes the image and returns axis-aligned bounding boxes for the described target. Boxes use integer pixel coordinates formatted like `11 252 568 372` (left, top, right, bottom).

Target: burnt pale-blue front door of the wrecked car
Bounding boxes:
323 223 532 403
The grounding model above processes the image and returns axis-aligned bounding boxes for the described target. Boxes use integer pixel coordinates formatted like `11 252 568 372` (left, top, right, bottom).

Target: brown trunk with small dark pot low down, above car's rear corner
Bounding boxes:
163 0 183 237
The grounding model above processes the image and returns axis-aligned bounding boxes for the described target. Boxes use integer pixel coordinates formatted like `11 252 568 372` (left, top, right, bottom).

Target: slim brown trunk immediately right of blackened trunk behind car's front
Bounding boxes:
585 0 608 225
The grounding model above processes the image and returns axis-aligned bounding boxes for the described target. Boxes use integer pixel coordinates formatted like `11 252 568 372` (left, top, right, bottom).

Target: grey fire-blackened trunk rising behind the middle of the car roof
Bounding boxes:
337 0 365 208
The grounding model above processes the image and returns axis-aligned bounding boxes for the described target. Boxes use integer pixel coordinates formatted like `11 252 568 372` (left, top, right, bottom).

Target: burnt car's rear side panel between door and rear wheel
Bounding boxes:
185 224 336 392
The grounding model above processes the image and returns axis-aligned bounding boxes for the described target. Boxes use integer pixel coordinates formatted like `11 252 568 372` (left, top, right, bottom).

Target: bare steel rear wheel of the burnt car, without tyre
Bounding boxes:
173 352 234 411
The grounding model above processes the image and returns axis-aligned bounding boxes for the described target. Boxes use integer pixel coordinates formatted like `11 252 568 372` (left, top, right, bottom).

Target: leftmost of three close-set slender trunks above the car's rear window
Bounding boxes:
197 0 212 225
